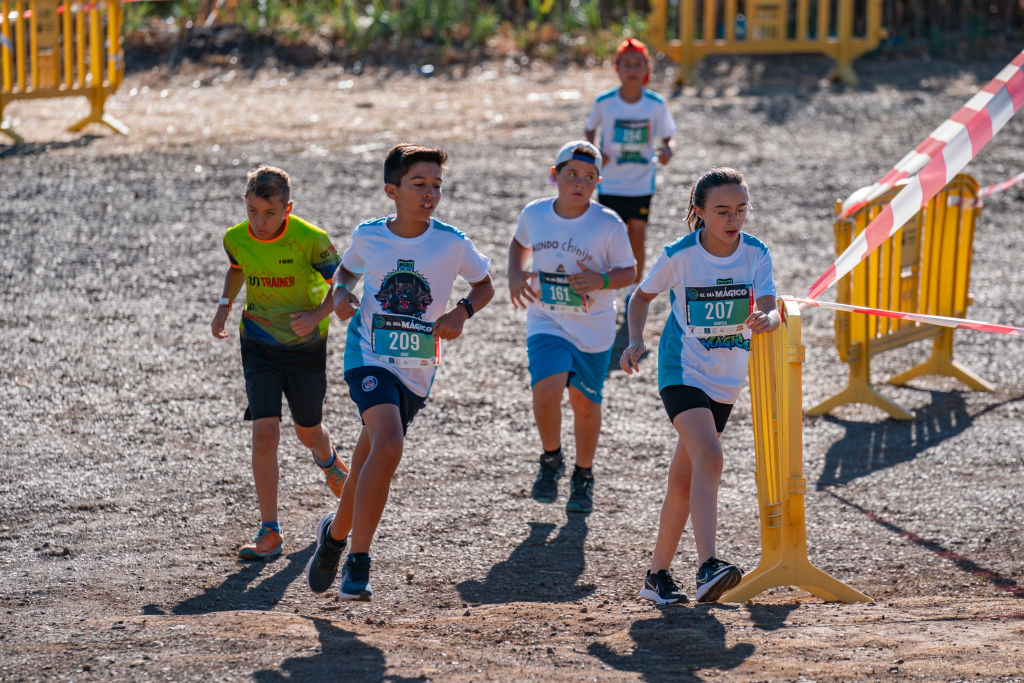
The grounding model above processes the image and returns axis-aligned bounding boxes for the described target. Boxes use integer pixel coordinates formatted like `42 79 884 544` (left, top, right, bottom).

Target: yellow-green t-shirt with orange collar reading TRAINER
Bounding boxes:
224 216 341 347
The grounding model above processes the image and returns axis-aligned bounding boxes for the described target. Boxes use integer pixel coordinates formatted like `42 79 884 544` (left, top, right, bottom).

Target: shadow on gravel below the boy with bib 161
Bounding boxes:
456 515 596 604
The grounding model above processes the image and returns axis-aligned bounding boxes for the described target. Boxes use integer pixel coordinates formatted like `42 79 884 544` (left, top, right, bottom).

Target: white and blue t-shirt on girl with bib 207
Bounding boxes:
640 230 775 403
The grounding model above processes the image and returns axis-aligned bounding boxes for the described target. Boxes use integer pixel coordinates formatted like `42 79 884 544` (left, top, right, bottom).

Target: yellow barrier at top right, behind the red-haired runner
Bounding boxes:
647 0 886 84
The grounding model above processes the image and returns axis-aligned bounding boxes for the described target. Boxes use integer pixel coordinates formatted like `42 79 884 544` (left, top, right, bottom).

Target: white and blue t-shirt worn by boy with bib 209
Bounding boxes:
341 216 490 397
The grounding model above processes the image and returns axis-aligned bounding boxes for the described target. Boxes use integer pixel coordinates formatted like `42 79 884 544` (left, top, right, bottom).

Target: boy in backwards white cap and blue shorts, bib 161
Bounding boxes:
508 140 636 514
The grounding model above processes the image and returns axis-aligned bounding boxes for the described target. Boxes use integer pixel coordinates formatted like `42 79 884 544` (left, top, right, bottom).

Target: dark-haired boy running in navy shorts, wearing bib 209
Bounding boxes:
306 144 495 601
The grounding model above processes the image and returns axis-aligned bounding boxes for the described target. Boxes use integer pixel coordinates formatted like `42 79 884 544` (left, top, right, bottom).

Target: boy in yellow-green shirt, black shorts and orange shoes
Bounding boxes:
212 166 348 560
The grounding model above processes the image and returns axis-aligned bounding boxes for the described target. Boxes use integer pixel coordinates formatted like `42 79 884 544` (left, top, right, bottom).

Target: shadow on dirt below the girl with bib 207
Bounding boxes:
587 605 755 681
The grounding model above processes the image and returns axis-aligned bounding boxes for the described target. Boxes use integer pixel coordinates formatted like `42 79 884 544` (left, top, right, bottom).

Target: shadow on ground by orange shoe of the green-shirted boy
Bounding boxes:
155 543 313 614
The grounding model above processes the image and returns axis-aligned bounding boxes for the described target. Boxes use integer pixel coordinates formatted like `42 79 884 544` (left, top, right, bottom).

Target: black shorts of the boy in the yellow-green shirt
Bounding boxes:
242 338 327 427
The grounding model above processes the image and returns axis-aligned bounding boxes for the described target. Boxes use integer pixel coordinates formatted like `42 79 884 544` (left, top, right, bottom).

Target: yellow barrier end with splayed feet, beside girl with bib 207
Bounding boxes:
720 300 871 602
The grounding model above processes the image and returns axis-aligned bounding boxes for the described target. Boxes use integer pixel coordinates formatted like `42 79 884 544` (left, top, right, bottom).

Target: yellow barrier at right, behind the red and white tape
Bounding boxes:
807 173 993 420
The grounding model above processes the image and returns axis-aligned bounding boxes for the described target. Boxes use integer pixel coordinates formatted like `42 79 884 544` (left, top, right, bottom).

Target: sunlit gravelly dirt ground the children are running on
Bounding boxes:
0 50 1024 681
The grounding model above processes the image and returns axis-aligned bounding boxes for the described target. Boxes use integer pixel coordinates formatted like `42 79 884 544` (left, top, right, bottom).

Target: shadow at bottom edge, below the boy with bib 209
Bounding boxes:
253 618 422 681
